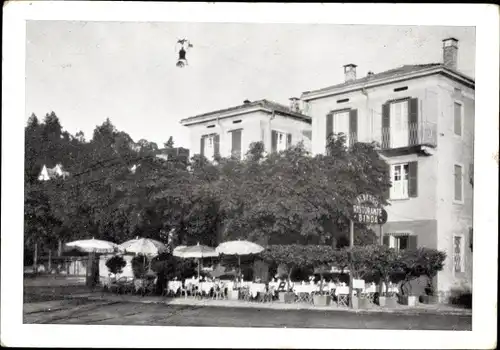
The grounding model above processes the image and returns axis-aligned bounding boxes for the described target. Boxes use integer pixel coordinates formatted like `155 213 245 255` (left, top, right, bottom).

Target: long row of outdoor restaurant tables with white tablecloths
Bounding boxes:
164 276 393 300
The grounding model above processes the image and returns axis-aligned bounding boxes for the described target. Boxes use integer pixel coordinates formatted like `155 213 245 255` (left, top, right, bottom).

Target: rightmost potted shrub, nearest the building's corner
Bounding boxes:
419 248 446 304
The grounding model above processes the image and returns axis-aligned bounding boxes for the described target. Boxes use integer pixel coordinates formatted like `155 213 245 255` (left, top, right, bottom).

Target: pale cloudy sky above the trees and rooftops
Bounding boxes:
25 21 476 148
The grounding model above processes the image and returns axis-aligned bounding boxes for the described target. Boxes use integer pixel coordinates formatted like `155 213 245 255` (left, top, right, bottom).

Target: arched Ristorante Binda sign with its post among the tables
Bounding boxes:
349 193 387 308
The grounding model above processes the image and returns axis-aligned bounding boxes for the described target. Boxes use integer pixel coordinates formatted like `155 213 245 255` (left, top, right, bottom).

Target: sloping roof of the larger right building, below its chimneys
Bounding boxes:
302 63 474 96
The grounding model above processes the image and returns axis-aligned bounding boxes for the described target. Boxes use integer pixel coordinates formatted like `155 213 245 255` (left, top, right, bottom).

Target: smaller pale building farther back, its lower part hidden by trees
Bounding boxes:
181 99 311 160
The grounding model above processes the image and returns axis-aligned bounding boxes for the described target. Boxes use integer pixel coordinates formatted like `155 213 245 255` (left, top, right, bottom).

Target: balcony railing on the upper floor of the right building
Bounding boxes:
377 123 437 149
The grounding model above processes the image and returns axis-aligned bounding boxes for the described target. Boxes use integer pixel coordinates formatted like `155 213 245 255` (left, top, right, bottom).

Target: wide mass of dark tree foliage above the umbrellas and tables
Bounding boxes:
25 112 390 260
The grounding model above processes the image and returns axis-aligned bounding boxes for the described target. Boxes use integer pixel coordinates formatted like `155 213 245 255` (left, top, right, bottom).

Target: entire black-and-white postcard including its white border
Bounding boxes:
1 2 498 349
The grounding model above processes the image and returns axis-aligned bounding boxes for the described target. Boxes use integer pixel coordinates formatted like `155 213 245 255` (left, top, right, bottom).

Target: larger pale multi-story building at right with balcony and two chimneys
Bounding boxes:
301 38 475 292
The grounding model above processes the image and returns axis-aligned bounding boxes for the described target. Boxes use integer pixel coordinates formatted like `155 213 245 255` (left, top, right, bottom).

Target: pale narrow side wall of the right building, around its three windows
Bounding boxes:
436 77 475 291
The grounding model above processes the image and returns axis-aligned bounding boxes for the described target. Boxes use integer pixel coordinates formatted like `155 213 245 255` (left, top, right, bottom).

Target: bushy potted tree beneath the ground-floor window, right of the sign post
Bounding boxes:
371 245 399 307
